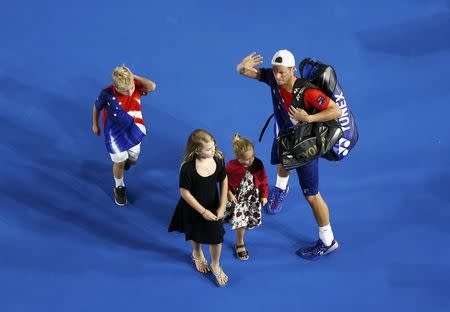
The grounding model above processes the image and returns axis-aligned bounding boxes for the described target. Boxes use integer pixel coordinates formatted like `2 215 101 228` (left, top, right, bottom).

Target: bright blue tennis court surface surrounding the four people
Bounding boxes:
0 0 450 312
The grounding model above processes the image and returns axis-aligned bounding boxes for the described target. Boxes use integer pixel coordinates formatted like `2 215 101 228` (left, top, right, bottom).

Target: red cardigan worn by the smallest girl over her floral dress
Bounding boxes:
225 157 269 198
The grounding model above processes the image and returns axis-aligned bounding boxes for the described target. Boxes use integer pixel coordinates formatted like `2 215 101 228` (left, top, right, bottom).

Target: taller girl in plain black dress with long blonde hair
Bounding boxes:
169 129 228 286
